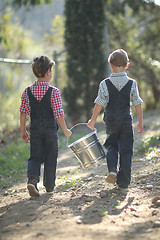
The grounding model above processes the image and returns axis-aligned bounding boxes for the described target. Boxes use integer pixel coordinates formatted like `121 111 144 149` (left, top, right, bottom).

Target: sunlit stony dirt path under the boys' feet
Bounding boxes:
0 112 160 240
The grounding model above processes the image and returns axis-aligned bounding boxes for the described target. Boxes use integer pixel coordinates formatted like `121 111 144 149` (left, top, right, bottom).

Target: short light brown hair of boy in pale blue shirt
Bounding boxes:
108 49 129 67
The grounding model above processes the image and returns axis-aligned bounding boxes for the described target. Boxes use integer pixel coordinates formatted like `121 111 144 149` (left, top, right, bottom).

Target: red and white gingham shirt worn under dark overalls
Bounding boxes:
20 81 64 118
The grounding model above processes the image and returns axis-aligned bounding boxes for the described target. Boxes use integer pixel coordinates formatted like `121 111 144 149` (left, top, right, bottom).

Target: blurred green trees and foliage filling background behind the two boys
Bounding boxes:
0 0 160 133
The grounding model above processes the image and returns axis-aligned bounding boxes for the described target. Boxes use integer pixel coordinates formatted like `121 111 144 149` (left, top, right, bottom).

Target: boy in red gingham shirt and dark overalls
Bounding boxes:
20 56 72 197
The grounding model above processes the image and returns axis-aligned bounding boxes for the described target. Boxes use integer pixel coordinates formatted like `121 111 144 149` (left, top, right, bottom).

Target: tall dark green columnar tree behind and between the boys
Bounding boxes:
64 0 106 123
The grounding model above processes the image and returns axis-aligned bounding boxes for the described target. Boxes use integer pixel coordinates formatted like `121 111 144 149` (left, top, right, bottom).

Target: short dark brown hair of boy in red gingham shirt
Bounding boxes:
32 56 55 78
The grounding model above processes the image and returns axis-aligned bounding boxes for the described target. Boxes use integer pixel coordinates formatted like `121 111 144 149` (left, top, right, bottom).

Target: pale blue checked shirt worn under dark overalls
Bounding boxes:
94 72 143 108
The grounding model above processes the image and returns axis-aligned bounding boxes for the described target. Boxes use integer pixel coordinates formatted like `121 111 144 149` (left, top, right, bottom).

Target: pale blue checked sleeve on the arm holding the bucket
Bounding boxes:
94 80 109 108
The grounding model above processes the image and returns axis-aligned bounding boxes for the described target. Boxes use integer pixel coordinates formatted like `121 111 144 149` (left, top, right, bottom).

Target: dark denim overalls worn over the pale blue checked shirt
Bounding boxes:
104 79 134 188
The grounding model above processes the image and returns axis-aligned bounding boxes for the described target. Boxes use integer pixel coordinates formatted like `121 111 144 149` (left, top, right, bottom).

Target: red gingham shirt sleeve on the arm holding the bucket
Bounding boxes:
51 88 64 118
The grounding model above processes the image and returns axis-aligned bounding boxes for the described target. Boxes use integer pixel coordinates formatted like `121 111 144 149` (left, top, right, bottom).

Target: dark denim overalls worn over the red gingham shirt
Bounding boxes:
27 87 58 188
